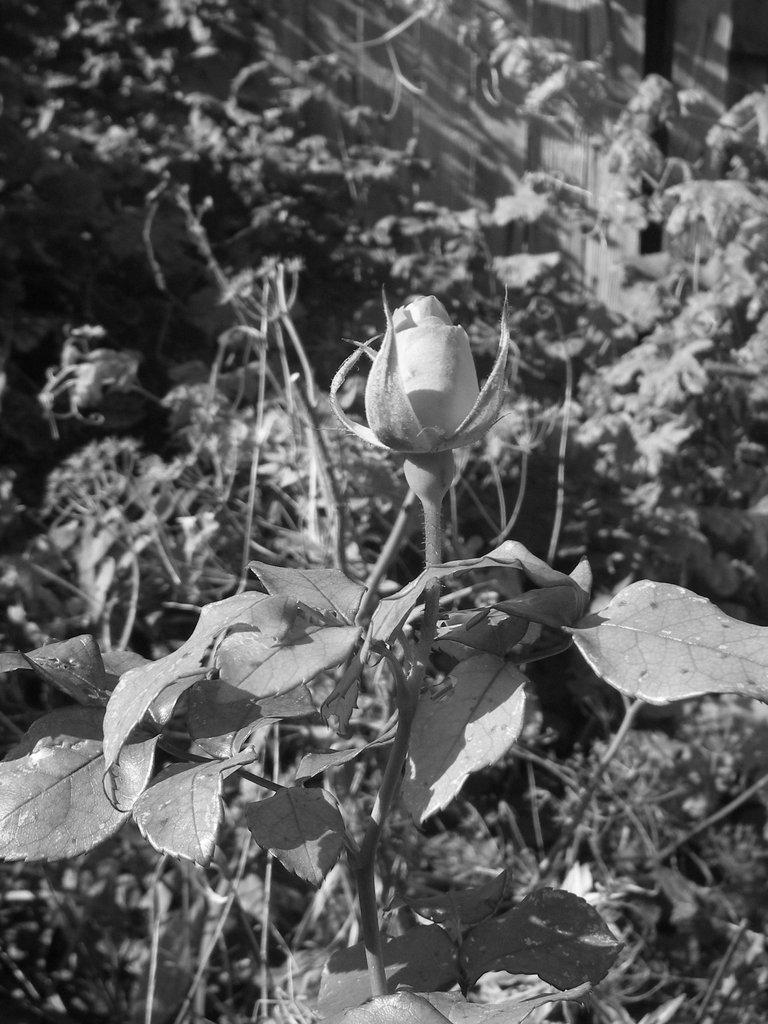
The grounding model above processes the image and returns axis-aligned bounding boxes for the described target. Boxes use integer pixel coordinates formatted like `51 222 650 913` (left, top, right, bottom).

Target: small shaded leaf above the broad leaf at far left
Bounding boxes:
23 633 117 708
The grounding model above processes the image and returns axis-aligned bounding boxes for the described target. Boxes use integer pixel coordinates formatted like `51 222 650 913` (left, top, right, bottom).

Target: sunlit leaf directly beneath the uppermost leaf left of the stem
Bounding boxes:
216 624 360 697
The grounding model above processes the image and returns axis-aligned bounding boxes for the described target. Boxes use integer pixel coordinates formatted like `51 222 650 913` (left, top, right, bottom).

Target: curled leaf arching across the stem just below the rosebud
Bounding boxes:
371 541 589 641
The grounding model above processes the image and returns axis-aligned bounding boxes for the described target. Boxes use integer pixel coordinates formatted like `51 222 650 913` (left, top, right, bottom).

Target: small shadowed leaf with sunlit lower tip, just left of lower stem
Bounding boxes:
246 787 345 886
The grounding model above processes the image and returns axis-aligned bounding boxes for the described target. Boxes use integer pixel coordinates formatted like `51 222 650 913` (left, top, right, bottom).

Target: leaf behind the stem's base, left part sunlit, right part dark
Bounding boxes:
317 925 457 1017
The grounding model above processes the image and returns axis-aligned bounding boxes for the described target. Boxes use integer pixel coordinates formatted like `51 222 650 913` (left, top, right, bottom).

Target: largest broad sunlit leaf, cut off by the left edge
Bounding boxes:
0 708 154 860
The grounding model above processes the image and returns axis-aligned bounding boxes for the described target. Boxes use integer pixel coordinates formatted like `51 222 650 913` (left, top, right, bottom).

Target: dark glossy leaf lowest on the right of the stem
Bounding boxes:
459 889 622 989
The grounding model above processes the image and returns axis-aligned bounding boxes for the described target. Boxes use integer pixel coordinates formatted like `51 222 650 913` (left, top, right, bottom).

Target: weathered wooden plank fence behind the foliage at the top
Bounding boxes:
260 0 753 304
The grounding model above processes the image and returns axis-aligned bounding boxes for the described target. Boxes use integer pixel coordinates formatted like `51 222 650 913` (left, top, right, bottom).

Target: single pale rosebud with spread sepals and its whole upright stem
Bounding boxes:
330 296 512 996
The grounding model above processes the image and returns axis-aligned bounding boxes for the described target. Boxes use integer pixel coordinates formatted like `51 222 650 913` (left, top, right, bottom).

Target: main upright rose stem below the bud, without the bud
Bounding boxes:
355 487 441 996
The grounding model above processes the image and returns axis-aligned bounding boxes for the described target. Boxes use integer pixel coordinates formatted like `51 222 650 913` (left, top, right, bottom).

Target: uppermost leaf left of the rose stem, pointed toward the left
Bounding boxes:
248 562 366 626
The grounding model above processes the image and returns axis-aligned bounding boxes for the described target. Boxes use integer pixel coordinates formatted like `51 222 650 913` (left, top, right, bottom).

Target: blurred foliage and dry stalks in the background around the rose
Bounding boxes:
0 0 768 1022
